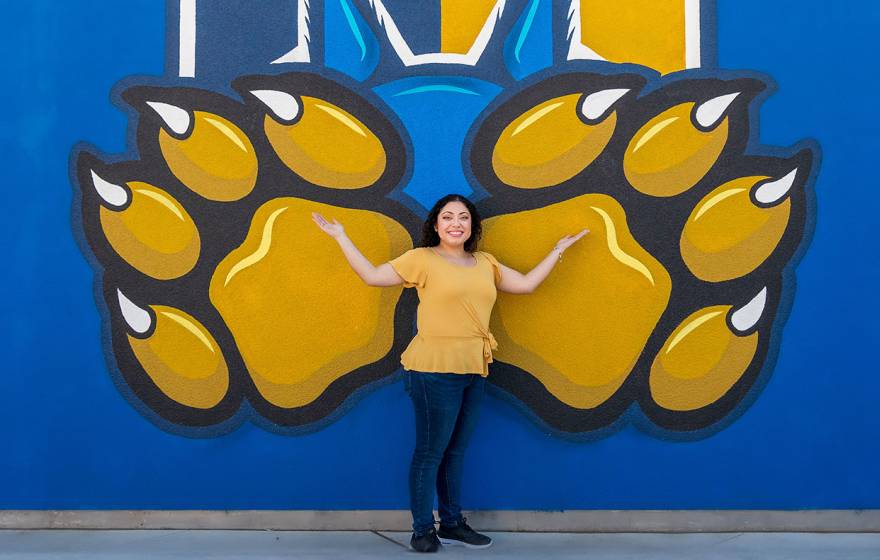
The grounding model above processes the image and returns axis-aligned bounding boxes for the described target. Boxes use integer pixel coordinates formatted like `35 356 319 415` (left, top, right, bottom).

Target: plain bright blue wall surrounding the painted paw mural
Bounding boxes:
0 0 880 509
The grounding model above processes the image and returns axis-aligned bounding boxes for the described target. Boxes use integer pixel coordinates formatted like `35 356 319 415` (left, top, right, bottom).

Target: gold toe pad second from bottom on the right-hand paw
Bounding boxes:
680 176 791 282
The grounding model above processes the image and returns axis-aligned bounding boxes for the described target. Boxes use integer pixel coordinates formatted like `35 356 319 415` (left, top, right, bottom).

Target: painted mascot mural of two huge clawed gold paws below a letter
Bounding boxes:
72 0 816 439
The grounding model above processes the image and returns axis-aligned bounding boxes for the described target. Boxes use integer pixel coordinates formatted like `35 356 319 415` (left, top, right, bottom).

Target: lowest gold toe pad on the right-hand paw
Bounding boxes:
650 305 758 411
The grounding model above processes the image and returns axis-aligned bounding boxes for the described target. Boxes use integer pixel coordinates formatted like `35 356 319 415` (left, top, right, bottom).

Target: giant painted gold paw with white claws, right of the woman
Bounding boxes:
469 72 813 434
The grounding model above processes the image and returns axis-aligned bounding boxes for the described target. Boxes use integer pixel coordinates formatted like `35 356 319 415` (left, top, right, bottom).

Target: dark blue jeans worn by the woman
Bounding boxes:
404 371 486 533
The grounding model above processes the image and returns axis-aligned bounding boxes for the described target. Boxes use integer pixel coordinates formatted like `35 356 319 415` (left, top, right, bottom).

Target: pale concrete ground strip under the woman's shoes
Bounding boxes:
0 529 880 560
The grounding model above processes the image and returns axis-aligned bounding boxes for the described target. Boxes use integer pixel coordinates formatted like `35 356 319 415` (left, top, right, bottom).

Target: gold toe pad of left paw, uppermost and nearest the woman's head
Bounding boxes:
264 96 387 189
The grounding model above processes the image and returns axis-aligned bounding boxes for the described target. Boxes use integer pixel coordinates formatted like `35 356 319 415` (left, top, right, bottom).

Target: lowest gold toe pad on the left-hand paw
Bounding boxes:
128 305 229 409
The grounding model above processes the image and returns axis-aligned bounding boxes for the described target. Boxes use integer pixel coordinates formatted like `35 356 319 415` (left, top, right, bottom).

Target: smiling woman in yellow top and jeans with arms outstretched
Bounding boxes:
312 194 587 552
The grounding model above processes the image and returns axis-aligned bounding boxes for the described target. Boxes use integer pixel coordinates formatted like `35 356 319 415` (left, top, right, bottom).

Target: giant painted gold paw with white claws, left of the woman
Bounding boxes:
76 73 419 426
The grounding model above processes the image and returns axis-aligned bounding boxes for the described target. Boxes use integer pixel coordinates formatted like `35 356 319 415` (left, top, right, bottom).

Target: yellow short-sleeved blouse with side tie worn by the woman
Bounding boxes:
390 247 501 377
